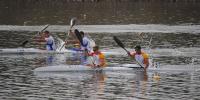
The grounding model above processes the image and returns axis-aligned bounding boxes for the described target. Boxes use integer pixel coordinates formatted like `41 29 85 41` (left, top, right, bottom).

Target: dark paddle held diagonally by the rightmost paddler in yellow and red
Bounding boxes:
113 36 143 68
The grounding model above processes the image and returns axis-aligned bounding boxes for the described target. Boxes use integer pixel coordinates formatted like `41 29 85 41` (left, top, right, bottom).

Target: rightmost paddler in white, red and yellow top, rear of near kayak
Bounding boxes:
128 45 149 71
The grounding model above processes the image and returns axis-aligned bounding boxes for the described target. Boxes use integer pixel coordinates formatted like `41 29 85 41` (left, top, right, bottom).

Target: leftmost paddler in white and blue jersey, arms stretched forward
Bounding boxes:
36 31 56 51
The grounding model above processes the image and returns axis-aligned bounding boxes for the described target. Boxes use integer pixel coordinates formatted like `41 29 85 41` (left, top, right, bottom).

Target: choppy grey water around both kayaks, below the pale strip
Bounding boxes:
0 27 200 100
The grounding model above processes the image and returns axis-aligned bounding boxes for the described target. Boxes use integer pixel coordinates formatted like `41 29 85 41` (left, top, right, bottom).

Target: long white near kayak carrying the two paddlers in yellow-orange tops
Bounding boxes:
34 64 199 72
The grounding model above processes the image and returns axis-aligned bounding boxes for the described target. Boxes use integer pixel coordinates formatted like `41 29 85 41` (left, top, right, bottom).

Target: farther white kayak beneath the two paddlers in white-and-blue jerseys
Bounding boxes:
0 48 119 55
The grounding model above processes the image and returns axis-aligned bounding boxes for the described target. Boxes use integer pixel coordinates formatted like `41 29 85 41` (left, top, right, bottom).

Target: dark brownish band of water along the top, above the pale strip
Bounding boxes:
0 0 200 25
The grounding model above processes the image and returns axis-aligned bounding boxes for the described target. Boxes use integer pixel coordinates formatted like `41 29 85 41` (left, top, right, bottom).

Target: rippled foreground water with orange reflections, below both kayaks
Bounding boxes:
0 54 200 100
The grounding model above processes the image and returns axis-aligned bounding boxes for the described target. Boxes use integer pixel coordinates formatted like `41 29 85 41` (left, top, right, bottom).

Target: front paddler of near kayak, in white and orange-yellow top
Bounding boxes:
87 46 106 68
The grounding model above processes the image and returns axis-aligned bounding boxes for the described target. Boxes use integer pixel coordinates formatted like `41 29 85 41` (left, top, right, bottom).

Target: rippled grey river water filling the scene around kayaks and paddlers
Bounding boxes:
0 0 200 100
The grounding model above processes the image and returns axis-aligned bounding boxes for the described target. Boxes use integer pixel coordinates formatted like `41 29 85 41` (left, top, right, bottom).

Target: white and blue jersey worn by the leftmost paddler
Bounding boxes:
45 36 56 50
